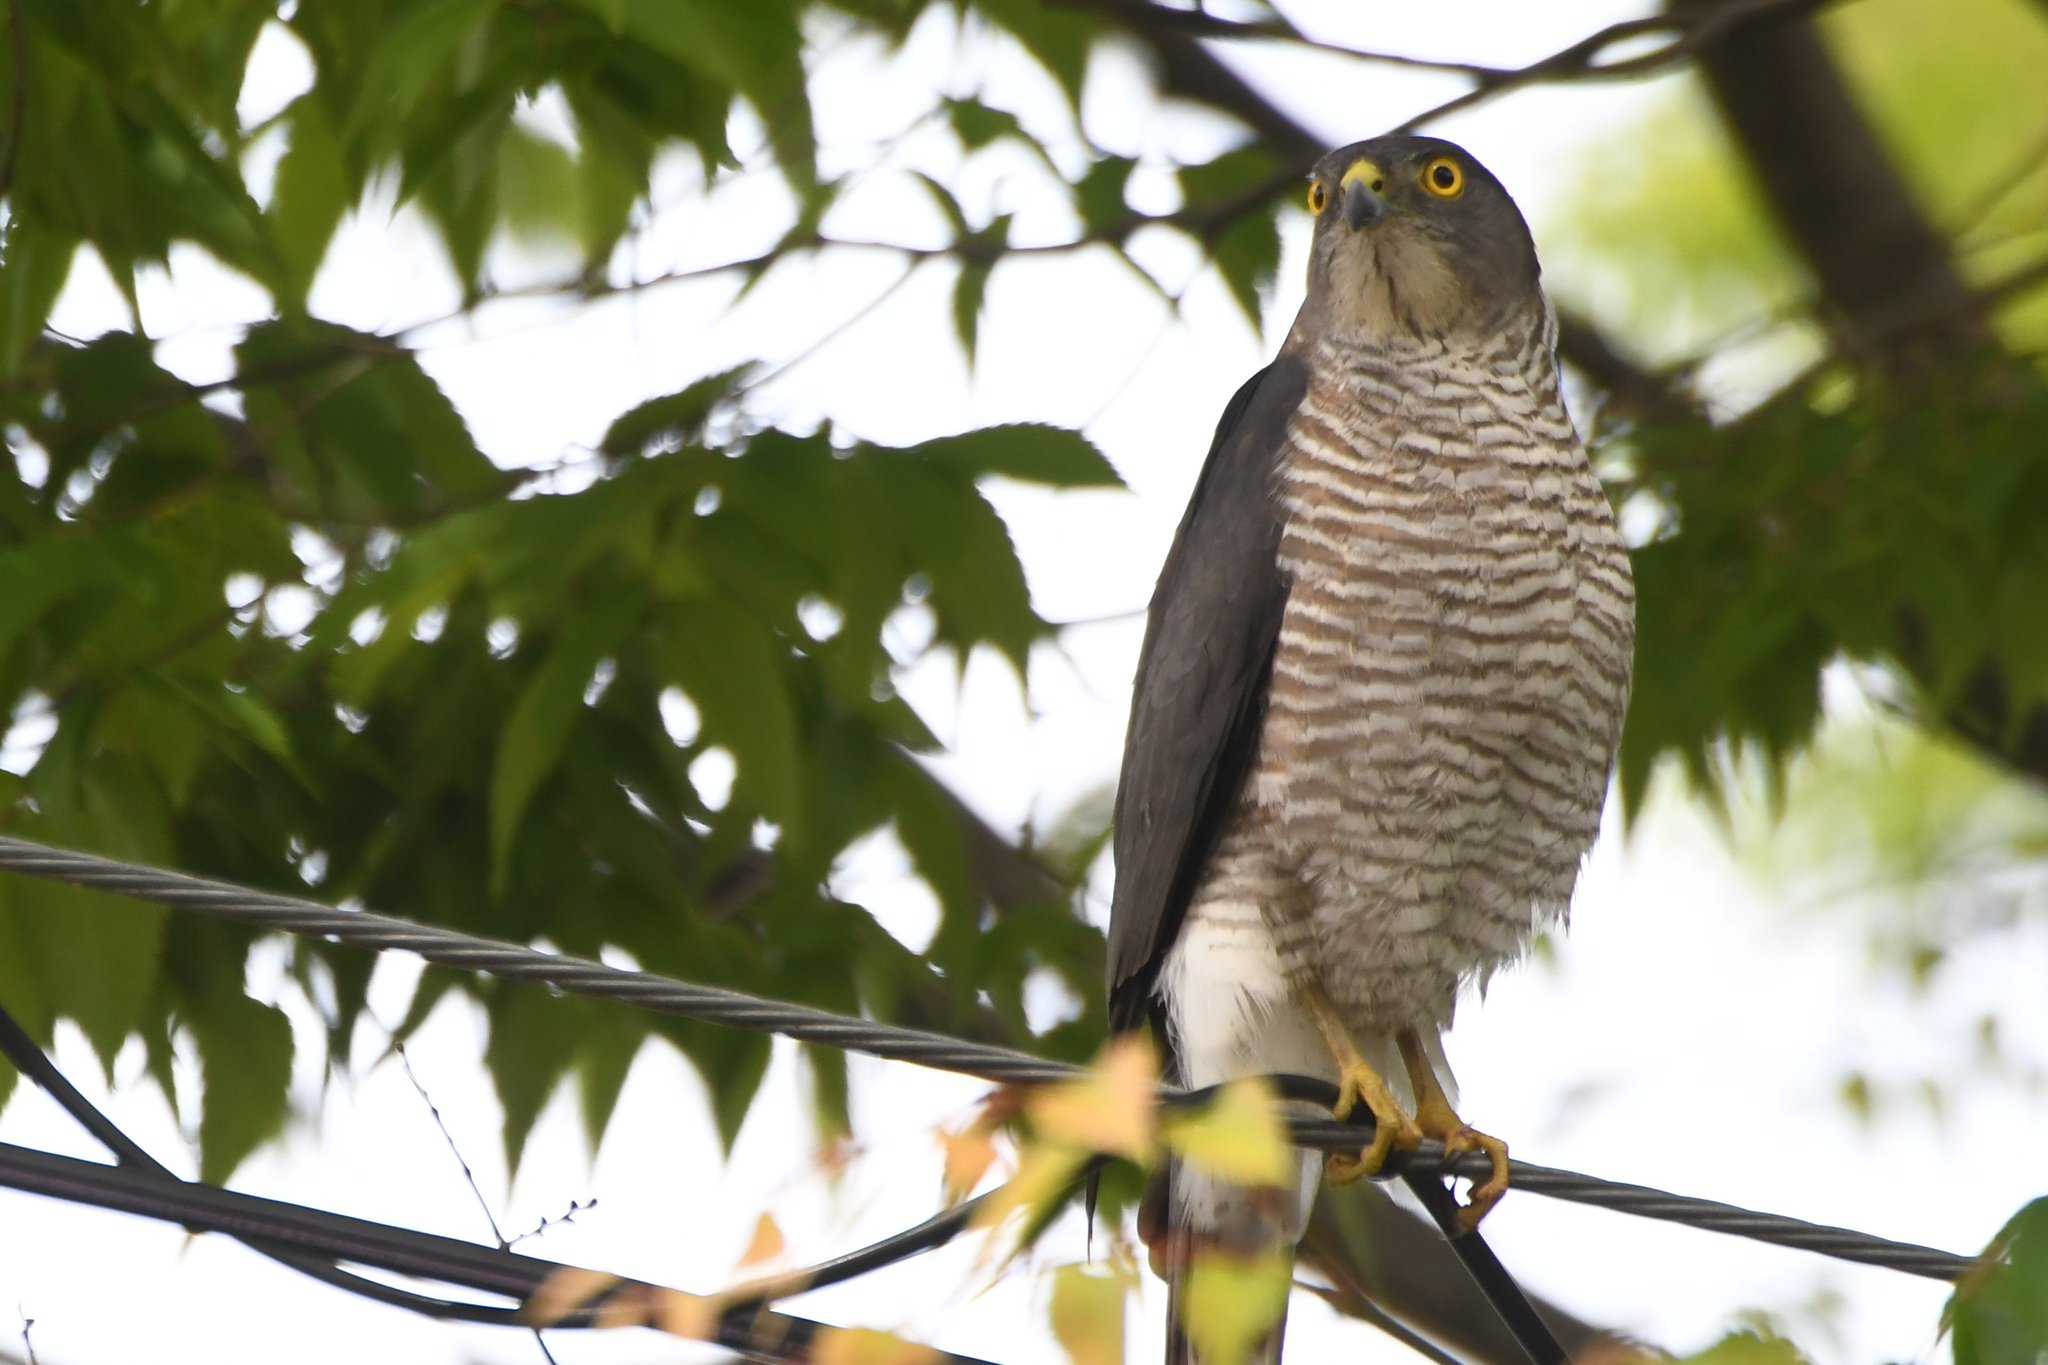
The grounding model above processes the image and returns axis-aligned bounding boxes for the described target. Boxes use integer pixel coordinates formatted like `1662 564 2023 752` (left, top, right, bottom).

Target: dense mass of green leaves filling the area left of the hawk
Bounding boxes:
0 0 1196 1179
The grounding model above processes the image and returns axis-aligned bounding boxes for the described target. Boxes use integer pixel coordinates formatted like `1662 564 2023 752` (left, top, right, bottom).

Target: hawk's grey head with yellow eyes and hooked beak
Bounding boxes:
1305 133 1542 338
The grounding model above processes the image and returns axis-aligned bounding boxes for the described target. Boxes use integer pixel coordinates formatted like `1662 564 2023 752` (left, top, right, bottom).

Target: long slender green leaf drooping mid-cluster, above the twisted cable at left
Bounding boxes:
492 589 643 894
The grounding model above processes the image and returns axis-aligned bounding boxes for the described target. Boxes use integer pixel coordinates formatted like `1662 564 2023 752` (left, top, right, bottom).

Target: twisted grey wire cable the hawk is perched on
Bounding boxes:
0 835 1972 1281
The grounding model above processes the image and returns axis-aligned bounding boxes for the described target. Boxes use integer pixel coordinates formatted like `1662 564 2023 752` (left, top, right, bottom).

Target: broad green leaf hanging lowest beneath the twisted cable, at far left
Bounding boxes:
184 990 293 1185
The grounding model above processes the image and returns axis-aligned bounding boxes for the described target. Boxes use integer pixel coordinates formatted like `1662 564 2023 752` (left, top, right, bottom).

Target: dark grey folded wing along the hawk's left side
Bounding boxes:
1110 356 1309 1031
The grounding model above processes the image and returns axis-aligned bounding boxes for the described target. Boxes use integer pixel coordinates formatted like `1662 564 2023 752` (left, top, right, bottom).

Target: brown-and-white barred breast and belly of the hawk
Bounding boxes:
1245 315 1634 1029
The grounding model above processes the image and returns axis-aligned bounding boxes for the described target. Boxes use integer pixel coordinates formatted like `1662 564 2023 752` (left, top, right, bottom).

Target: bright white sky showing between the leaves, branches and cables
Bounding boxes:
0 0 2048 1365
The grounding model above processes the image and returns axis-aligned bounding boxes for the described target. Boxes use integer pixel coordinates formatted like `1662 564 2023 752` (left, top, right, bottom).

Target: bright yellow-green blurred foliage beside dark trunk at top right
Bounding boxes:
1544 0 2048 362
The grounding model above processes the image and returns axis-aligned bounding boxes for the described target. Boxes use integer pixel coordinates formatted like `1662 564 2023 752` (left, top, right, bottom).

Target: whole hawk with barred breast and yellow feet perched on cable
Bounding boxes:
1108 135 1634 1361
